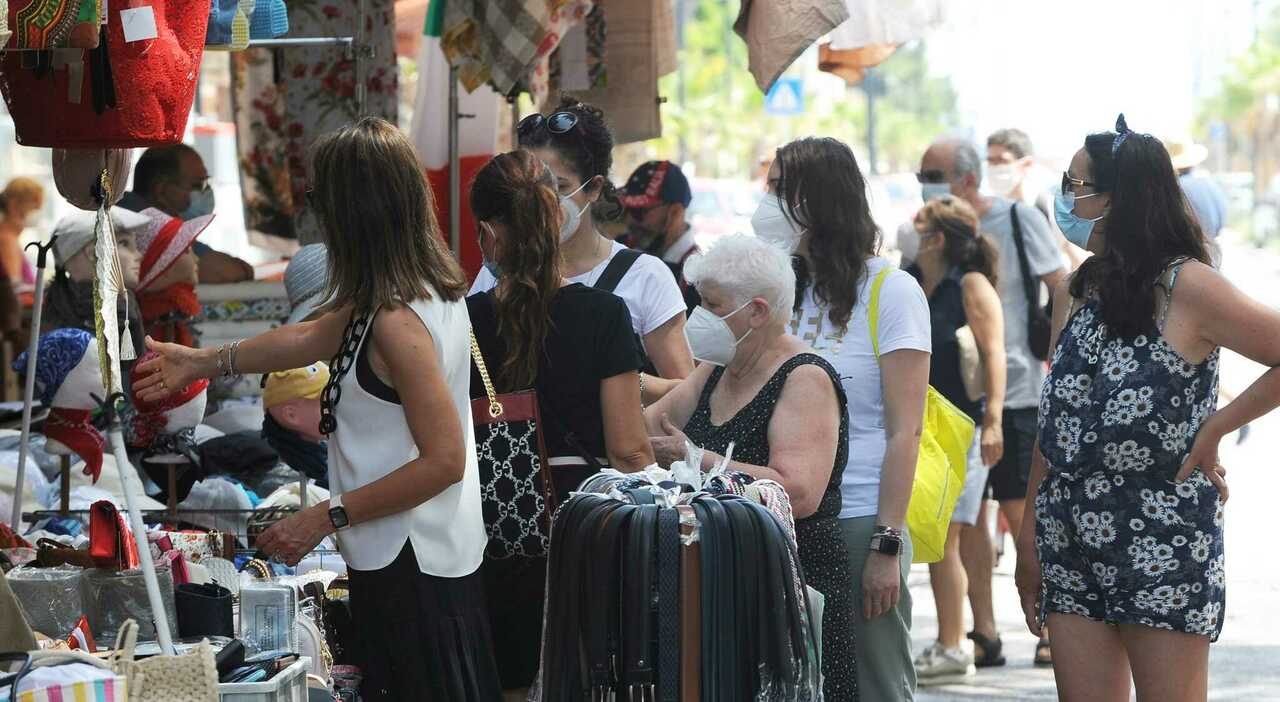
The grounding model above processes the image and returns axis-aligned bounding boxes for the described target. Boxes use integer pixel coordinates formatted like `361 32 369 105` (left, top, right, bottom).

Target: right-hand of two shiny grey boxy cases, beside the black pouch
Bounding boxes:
81 567 178 642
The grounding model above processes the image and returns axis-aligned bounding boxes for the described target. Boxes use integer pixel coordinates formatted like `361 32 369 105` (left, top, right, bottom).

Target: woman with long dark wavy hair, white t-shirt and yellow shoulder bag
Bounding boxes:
751 138 932 699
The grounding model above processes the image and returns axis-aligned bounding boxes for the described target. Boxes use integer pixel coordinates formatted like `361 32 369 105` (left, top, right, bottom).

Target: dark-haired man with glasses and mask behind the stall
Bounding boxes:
120 143 253 283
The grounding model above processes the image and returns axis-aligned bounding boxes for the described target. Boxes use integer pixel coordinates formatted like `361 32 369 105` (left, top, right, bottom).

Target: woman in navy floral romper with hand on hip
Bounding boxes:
1018 118 1280 702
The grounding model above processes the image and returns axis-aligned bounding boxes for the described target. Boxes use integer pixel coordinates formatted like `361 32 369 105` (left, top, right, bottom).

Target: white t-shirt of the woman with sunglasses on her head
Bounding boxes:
470 242 685 337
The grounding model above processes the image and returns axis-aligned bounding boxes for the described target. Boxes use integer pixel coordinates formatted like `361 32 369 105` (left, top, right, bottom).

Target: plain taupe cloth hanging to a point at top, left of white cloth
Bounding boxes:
733 0 849 92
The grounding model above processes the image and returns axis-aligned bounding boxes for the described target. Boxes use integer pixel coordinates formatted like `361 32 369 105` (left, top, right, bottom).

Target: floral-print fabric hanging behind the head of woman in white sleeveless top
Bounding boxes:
232 0 399 240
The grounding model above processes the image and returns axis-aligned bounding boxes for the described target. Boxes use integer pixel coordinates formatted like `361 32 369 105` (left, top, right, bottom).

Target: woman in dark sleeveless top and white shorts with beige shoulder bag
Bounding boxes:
906 195 1005 685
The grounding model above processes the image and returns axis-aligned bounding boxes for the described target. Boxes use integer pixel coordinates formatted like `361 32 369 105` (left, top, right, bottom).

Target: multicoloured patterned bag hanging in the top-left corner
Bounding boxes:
0 0 104 51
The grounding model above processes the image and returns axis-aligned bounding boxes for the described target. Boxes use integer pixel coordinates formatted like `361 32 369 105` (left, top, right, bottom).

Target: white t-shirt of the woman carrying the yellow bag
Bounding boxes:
791 256 932 519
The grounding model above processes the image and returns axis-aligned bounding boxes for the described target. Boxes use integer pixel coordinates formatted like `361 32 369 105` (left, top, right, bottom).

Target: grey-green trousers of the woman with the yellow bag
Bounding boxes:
840 516 915 702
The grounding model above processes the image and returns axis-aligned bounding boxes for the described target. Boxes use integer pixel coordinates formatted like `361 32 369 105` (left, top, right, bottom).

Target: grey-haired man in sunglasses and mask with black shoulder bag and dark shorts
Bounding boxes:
919 140 1066 666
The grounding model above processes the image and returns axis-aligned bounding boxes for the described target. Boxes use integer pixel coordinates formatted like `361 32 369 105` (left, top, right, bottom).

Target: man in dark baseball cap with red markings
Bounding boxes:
620 161 701 311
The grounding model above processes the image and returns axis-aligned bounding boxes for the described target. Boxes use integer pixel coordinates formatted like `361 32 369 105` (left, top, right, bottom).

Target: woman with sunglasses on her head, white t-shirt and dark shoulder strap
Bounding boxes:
468 97 694 405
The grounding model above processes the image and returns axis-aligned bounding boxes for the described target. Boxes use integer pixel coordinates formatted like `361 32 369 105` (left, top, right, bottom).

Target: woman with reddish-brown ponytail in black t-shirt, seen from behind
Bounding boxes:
467 151 654 690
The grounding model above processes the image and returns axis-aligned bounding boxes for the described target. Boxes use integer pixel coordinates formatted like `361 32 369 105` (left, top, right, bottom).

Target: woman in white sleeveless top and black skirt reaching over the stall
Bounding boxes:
134 118 500 701
